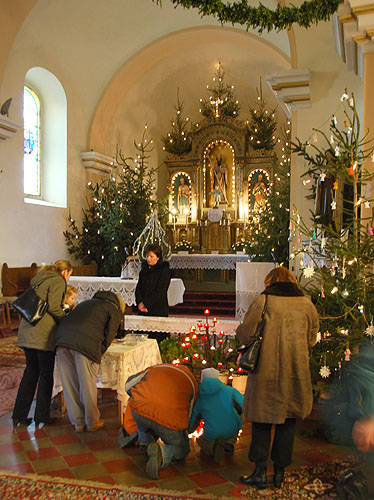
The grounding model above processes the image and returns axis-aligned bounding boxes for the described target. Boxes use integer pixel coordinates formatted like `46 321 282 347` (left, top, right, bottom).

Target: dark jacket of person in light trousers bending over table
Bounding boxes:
56 291 123 363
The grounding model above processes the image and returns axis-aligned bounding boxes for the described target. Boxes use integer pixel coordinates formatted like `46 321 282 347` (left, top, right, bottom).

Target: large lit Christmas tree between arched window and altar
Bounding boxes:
64 126 159 276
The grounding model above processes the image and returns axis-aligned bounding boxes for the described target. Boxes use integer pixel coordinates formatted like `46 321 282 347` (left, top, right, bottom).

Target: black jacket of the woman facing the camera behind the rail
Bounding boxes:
135 260 170 316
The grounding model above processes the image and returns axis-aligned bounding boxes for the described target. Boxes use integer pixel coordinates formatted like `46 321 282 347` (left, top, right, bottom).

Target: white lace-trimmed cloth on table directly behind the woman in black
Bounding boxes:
69 276 185 306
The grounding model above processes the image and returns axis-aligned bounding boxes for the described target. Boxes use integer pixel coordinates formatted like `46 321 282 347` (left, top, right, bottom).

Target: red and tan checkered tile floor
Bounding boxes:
0 390 352 497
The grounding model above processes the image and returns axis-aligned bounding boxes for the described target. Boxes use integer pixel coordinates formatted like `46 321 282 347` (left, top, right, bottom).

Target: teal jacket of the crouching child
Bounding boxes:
189 378 243 441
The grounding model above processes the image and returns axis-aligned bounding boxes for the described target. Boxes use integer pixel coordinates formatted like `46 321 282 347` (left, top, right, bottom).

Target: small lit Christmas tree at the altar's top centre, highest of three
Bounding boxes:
199 63 240 120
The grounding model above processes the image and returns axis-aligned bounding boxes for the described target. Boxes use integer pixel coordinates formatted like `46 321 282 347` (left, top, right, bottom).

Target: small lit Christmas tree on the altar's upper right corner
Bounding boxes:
248 79 277 151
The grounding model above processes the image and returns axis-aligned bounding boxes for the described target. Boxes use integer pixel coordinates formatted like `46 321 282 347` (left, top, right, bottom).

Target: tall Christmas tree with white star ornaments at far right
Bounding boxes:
291 91 374 381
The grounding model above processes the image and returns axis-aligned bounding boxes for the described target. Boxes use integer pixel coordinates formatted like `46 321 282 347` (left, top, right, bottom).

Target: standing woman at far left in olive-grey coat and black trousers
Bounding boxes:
12 260 73 427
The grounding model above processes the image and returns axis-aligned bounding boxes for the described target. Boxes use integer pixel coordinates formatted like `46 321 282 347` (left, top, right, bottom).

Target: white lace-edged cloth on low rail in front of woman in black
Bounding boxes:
125 315 239 336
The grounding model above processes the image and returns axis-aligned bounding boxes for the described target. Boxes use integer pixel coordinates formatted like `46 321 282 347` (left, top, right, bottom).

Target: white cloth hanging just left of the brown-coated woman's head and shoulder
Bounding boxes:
235 262 275 321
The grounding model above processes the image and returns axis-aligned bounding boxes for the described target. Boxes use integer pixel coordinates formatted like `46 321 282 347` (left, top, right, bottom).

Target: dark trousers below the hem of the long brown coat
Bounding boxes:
248 418 296 467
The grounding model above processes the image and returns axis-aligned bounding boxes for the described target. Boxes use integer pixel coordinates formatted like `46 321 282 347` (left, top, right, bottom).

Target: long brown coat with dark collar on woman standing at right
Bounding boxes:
236 282 319 424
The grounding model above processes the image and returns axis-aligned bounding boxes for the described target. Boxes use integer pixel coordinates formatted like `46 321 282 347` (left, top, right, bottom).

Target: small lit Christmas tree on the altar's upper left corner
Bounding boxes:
161 89 192 155
